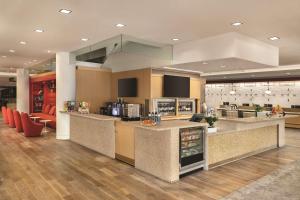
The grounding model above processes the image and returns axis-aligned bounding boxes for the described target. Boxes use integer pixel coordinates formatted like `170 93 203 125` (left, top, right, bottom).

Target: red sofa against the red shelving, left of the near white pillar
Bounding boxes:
31 105 56 129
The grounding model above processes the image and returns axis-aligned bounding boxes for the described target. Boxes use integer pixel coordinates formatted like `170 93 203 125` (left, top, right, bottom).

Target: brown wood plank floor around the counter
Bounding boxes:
0 124 300 200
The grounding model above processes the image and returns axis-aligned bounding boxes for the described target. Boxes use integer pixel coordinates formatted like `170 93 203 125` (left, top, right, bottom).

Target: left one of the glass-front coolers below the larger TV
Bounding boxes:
152 98 176 116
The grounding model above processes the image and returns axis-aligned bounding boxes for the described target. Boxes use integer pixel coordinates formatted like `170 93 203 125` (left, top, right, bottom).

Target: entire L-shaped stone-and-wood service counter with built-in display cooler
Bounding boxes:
62 112 285 182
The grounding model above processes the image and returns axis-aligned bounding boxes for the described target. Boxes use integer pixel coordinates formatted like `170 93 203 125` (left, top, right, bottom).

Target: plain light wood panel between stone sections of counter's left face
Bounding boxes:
116 122 134 164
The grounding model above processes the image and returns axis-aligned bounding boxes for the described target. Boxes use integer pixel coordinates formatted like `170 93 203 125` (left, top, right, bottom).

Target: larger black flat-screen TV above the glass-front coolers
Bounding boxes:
163 75 190 98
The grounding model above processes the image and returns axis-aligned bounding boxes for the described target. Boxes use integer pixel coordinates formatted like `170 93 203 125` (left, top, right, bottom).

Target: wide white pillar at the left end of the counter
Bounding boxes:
56 52 76 140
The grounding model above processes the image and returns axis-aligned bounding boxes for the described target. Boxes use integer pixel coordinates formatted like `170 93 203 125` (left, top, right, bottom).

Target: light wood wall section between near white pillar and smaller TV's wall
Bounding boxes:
76 66 112 113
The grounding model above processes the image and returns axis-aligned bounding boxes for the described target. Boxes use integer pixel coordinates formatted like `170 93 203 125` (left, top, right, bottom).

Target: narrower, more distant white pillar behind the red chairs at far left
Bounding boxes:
17 69 30 113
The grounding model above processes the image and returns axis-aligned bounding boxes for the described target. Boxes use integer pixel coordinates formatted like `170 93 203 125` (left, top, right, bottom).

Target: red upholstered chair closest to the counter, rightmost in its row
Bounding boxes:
21 113 44 137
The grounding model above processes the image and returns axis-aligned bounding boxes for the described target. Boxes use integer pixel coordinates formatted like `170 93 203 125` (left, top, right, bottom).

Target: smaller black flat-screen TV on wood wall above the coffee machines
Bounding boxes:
118 78 137 97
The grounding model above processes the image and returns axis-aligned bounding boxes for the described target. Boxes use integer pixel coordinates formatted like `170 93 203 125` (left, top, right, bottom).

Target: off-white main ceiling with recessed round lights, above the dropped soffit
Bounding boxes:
0 0 300 71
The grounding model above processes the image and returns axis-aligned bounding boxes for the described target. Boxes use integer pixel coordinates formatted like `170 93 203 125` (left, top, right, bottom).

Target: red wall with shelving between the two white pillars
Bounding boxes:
30 73 56 113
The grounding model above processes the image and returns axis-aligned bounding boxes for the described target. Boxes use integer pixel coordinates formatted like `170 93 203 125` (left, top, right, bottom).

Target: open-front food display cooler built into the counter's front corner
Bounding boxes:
179 127 205 175
